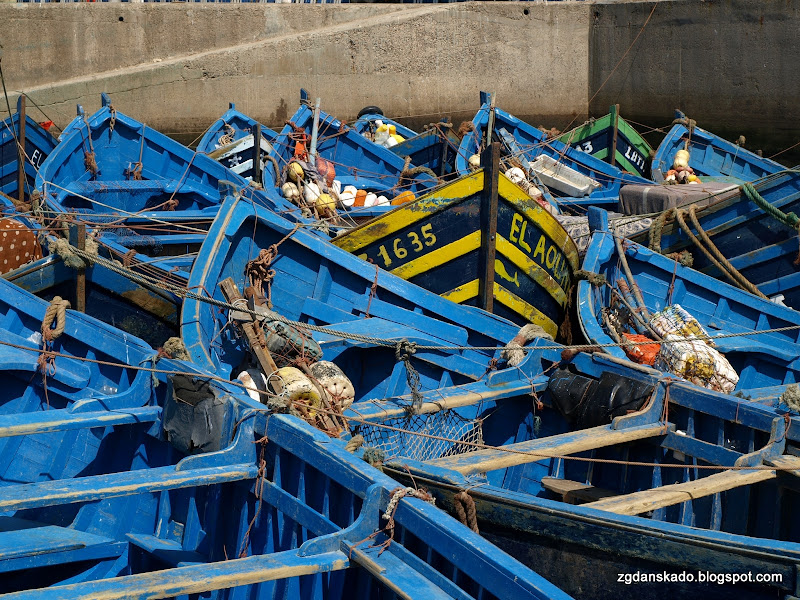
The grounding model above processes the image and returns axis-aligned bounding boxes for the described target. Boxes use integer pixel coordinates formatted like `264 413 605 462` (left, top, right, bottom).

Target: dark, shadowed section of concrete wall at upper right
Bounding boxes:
588 0 800 157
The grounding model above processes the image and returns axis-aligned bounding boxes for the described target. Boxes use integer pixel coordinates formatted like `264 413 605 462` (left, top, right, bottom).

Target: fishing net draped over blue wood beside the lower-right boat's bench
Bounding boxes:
356 410 483 461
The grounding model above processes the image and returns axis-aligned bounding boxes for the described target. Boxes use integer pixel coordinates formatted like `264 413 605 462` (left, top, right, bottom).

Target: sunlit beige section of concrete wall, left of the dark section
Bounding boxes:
0 2 589 133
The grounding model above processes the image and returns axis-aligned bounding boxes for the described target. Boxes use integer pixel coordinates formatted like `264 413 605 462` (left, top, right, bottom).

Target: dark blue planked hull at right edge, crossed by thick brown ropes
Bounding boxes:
633 170 800 309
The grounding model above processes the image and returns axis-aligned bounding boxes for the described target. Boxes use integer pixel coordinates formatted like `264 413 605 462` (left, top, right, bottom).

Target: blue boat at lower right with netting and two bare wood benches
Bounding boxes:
346 340 800 600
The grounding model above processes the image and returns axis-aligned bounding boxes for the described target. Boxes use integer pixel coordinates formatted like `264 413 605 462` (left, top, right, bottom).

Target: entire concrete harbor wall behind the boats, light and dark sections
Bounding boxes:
0 0 800 152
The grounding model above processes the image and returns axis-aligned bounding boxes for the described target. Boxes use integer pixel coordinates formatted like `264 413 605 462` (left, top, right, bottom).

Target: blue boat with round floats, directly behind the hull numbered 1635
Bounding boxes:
264 90 438 224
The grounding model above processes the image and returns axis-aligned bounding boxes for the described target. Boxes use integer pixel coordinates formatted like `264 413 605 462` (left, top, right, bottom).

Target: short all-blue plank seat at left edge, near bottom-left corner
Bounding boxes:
0 517 127 573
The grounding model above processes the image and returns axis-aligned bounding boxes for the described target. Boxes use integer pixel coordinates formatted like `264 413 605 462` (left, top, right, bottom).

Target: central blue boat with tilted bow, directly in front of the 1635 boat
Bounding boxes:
181 190 518 390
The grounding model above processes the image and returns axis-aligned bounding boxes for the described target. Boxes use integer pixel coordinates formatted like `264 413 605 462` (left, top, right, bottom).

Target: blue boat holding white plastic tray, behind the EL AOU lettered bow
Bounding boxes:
456 93 650 214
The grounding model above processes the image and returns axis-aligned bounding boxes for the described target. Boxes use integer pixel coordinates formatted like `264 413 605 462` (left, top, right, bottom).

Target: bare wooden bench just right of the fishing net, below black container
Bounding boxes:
428 423 667 475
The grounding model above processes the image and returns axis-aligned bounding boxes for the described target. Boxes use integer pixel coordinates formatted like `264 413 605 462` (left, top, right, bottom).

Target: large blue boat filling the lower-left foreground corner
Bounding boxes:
0 282 569 600
